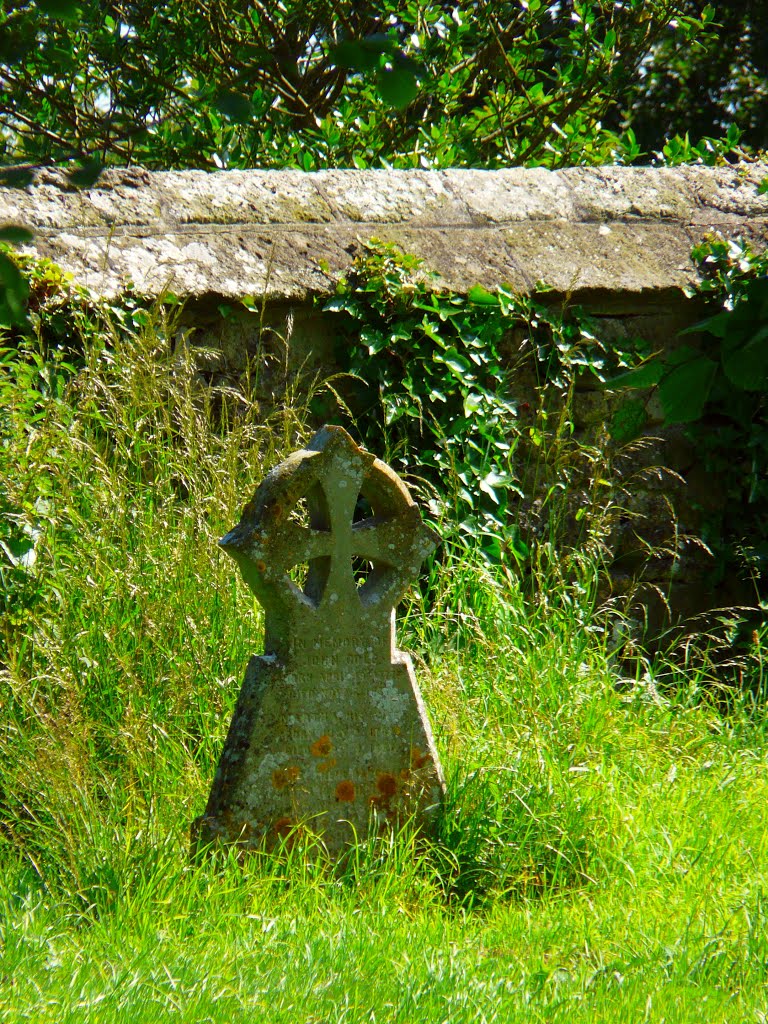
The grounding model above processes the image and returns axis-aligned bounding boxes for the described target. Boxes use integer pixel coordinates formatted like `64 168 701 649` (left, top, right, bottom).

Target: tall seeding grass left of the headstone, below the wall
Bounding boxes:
2 308 313 889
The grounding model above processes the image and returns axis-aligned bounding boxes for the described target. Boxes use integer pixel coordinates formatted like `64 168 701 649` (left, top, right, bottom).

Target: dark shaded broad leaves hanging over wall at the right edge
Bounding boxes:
608 238 768 596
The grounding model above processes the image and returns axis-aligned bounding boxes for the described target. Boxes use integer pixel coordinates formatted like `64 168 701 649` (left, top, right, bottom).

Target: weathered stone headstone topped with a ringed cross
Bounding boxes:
193 426 444 855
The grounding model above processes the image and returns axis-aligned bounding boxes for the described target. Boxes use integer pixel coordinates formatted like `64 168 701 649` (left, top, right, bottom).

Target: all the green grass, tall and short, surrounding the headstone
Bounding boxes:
0 314 768 1024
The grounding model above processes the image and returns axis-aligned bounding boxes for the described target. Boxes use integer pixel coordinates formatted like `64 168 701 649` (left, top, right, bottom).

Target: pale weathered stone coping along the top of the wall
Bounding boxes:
0 164 768 314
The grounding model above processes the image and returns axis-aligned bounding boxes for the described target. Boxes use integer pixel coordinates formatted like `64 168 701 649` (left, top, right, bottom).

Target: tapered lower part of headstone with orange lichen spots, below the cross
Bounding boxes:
191 649 444 855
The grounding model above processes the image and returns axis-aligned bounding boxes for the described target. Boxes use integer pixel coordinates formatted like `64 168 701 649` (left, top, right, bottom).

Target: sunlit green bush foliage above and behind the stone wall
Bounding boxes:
0 0 745 172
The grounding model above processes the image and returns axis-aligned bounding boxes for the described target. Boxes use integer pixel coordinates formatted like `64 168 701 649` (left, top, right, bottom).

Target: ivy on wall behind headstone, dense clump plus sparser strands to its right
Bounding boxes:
324 242 621 562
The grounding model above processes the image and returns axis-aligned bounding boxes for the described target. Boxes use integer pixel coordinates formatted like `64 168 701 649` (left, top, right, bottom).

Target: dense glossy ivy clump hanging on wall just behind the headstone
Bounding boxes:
324 243 517 557
